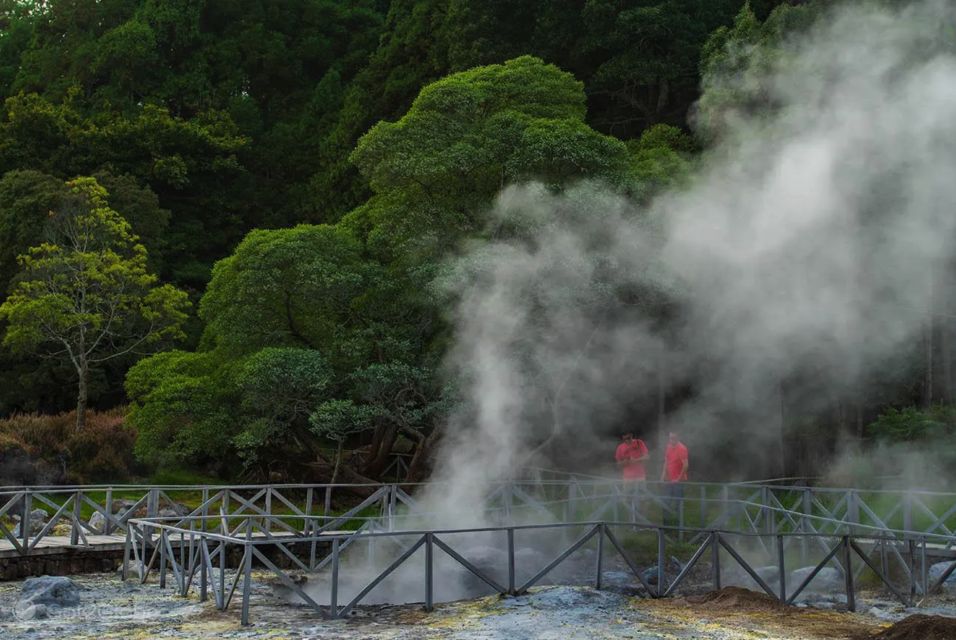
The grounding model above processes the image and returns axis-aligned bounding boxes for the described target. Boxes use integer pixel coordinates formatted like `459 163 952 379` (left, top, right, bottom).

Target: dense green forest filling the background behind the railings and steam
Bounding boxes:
0 0 956 482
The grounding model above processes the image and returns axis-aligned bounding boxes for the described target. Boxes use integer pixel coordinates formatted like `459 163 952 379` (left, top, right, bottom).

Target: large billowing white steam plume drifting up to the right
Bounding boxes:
429 2 956 523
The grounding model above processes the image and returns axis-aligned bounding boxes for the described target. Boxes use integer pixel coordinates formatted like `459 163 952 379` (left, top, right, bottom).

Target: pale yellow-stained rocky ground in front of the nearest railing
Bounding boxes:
0 575 956 640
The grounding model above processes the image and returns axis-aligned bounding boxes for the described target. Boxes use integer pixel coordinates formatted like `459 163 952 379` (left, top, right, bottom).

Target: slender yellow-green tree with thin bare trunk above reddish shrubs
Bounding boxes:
0 178 188 430
